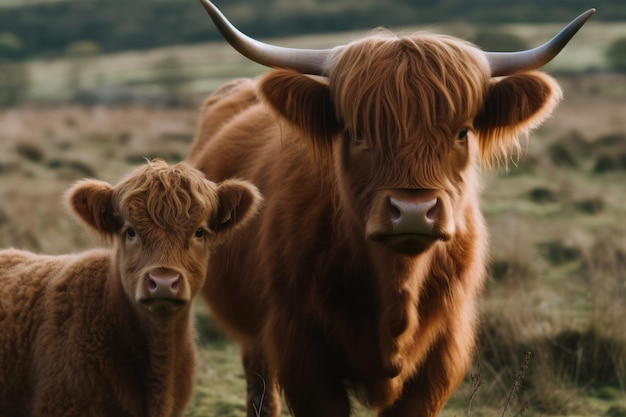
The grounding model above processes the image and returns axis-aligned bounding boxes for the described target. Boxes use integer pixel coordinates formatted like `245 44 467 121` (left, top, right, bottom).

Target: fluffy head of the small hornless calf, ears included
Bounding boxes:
69 161 260 315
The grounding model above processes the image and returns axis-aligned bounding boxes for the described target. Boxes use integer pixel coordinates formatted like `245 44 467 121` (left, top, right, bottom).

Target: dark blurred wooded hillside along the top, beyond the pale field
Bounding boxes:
0 0 626 60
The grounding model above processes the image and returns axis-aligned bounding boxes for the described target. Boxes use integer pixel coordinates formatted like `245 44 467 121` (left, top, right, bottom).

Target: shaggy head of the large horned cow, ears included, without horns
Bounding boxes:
260 34 560 255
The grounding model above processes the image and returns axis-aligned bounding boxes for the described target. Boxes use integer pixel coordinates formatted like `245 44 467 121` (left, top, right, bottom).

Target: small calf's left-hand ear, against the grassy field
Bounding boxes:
66 180 121 238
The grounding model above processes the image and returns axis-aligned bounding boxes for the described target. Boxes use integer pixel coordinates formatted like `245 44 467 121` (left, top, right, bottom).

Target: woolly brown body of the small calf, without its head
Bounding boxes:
0 249 195 416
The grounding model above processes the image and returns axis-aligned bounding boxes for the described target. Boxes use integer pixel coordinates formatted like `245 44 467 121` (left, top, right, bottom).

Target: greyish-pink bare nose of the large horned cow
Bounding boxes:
388 197 441 235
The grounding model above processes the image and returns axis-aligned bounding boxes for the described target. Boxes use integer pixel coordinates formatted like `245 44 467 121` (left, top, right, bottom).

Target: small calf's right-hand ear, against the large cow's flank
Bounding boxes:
209 180 263 236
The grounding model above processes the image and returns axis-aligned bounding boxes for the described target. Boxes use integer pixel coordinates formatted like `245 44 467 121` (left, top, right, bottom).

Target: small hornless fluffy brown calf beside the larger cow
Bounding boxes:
0 161 260 417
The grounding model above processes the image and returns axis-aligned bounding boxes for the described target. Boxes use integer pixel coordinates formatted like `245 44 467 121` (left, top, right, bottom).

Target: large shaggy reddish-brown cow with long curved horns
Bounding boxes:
188 0 593 417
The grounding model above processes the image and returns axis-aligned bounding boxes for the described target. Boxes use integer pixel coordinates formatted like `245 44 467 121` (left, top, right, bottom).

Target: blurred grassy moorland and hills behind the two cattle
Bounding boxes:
0 0 626 417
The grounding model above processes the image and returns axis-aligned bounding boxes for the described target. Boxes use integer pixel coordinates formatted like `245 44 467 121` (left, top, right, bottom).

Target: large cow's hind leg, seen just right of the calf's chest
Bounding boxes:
242 347 280 417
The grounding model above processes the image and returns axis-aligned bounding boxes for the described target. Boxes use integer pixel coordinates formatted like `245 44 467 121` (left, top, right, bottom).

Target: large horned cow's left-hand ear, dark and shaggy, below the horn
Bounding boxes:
259 70 340 146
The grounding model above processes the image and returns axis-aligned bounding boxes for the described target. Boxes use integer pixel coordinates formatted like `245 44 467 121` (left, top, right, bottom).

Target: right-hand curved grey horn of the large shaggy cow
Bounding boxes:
486 9 596 77
